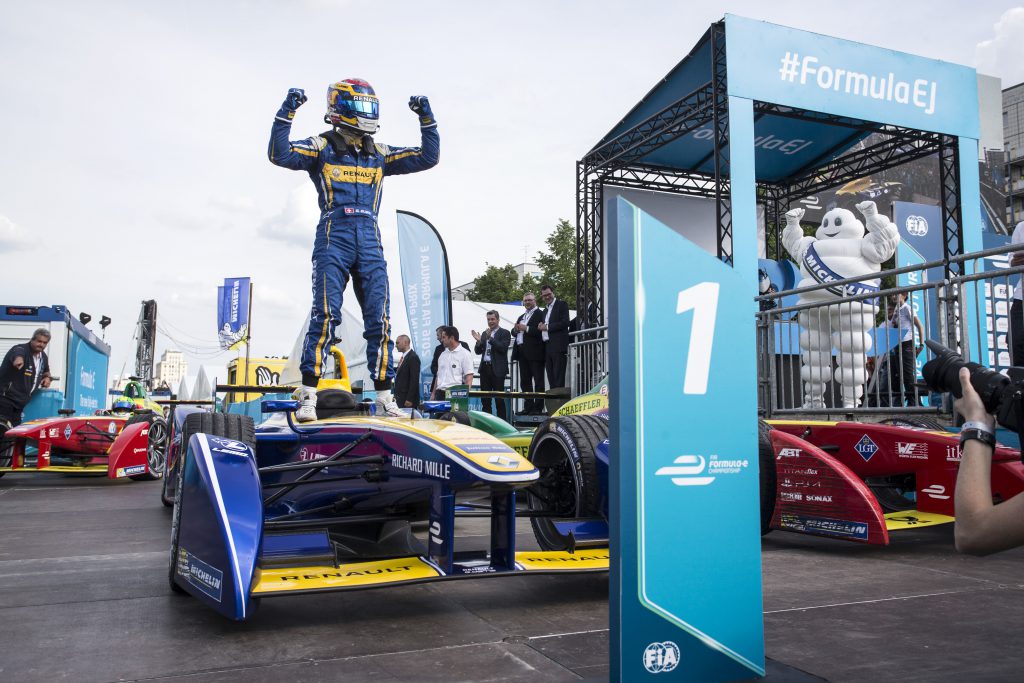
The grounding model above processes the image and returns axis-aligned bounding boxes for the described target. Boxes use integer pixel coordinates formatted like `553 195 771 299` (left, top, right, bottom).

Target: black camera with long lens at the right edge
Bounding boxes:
921 340 1024 438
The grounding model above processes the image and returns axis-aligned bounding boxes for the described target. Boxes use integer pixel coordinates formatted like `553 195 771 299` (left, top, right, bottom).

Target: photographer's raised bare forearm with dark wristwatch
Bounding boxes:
953 368 1024 555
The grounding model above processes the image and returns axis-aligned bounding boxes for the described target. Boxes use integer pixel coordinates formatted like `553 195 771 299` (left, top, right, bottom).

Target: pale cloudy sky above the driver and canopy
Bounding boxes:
0 0 1024 385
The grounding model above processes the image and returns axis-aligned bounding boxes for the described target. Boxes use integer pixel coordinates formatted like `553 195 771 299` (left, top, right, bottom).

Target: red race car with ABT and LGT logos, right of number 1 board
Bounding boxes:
767 419 1024 545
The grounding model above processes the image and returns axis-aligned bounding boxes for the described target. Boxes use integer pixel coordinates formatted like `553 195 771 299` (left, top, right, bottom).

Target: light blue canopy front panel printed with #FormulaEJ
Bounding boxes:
725 14 979 139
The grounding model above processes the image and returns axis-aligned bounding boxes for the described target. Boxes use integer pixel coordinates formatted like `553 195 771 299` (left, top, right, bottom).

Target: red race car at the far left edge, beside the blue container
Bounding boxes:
0 411 167 480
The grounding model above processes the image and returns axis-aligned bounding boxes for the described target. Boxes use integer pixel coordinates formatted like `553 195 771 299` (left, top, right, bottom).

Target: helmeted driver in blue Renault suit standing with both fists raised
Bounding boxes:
268 79 440 422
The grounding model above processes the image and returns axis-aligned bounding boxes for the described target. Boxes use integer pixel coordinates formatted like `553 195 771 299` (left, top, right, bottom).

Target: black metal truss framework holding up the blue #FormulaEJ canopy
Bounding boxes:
577 22 964 327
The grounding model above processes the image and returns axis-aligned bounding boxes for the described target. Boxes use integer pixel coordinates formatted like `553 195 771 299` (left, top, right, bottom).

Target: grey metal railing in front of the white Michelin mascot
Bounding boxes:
757 240 1024 420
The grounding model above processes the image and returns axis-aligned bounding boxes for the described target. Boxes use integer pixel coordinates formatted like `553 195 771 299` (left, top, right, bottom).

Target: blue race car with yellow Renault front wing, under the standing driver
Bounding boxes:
169 389 608 620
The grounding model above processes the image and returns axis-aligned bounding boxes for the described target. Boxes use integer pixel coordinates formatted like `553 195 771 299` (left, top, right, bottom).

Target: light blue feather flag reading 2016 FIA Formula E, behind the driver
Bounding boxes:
398 211 452 396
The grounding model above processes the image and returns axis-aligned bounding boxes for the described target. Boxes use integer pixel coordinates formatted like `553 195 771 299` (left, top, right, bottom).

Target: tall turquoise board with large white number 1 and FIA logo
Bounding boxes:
608 194 764 681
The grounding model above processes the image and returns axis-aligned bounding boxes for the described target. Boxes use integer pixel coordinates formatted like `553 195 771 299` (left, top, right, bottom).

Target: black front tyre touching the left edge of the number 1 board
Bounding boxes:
526 415 608 550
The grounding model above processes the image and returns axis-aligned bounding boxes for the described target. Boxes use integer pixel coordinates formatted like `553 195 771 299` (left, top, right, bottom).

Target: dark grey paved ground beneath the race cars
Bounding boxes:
0 474 1024 683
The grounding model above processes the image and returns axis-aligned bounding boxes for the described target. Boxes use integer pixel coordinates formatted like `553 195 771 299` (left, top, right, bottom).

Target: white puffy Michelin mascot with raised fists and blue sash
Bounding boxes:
782 202 899 410
